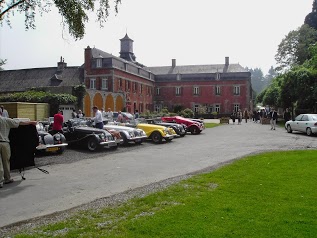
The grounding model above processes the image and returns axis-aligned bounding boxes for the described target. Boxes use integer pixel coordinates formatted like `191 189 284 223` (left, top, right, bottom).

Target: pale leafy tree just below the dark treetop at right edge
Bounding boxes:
275 24 317 72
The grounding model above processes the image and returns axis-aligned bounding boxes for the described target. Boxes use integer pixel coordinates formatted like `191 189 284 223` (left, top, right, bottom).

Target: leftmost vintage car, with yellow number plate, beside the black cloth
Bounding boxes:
36 123 68 154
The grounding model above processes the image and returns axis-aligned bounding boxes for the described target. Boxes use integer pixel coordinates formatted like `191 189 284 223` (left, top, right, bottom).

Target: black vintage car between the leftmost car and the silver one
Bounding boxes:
63 119 122 151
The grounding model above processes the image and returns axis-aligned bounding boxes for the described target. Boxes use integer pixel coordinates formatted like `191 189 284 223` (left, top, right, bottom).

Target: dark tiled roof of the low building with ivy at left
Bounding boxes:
0 67 83 92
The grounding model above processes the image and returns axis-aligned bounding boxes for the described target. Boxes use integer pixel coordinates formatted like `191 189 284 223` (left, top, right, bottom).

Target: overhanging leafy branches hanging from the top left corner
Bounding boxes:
0 0 121 39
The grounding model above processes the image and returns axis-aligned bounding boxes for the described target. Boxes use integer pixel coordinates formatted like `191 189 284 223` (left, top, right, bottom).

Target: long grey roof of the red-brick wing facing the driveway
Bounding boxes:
145 64 248 75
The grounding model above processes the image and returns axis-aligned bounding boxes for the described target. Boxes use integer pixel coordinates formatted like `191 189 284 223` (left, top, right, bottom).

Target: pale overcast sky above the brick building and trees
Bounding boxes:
0 0 313 74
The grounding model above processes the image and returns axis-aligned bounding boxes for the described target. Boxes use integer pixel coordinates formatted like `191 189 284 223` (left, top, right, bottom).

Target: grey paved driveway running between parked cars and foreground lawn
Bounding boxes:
0 122 317 227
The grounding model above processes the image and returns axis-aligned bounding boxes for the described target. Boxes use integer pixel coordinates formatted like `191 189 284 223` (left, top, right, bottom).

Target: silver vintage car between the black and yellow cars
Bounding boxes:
103 122 147 145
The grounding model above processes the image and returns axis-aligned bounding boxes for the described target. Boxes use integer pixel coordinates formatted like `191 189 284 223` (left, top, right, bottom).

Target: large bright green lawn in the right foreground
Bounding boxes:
13 150 317 238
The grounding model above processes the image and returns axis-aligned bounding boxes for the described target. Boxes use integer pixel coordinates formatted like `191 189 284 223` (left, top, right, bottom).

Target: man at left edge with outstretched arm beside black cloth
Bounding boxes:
0 117 37 188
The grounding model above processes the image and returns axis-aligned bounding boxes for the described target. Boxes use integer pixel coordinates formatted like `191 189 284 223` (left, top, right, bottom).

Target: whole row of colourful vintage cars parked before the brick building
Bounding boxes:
33 112 204 153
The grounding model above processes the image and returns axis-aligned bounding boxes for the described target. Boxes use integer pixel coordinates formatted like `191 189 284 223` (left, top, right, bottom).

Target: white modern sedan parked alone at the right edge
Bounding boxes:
285 114 317 136
